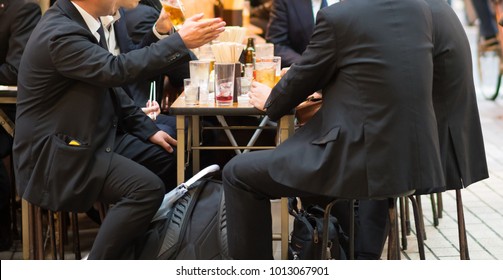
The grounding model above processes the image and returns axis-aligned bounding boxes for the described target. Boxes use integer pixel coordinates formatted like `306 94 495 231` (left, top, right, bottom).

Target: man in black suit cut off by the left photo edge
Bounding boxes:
0 0 41 251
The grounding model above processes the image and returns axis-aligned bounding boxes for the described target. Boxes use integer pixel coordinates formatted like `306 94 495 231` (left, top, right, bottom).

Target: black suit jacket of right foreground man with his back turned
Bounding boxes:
266 0 445 198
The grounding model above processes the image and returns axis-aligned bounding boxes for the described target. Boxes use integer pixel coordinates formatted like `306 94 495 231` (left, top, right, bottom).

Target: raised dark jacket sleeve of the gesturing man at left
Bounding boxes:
48 26 190 88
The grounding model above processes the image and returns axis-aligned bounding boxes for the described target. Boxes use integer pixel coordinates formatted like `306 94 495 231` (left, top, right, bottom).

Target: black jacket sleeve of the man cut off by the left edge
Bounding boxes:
0 2 41 85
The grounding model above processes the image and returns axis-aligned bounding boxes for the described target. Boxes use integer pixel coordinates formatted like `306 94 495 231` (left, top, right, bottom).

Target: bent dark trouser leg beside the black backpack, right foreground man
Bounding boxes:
223 151 312 259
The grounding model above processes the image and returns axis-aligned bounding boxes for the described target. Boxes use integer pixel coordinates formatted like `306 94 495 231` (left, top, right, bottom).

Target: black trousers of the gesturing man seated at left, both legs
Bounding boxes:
88 134 176 259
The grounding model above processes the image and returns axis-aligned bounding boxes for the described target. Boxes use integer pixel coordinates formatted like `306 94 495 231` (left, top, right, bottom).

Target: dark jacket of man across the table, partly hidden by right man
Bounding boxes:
266 0 314 67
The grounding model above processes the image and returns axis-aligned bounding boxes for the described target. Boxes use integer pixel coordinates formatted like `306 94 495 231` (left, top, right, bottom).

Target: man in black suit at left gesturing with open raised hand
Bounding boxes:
13 0 225 259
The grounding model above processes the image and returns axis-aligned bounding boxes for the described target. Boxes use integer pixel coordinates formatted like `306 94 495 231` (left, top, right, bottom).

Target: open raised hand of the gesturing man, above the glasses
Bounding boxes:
178 13 225 49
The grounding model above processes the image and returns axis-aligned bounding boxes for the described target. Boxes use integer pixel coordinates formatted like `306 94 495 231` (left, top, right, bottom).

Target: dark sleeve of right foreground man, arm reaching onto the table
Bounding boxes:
265 11 338 120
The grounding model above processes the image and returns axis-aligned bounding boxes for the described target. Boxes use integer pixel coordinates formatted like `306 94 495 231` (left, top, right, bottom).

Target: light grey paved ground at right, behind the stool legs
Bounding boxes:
0 0 503 260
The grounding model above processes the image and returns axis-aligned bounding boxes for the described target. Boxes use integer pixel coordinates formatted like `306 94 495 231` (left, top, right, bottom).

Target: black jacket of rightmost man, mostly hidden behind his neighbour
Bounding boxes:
425 0 489 189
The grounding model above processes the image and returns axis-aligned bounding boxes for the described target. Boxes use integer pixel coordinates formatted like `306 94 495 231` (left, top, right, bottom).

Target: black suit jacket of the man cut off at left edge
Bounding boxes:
0 0 41 85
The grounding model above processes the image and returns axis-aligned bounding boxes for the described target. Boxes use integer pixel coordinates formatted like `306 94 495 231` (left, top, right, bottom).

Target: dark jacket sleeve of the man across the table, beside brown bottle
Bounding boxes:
266 0 301 65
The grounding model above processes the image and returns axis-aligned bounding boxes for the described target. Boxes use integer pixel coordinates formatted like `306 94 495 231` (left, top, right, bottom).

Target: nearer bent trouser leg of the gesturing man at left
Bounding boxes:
89 154 164 259
